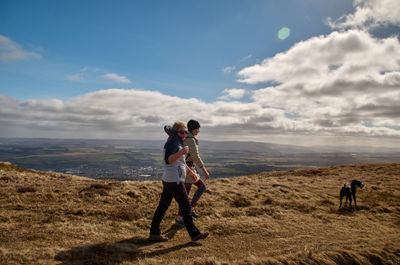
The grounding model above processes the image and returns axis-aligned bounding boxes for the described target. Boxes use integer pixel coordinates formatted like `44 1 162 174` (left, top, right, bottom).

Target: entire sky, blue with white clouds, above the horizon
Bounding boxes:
0 0 400 145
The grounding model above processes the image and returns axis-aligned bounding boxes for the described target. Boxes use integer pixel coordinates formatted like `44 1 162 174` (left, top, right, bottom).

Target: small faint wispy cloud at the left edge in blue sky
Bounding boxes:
0 35 42 62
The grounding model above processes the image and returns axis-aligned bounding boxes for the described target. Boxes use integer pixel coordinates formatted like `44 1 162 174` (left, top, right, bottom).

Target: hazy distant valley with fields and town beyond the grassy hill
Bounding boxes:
0 138 400 180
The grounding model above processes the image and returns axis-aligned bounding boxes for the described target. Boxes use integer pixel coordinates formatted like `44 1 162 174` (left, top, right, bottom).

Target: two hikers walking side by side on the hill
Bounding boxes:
150 120 210 241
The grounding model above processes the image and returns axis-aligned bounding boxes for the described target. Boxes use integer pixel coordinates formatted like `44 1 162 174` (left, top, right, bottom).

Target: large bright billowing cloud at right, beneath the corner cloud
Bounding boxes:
238 30 400 85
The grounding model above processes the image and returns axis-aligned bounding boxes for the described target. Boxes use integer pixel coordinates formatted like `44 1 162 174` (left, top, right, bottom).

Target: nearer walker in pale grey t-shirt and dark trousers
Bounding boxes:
150 122 208 241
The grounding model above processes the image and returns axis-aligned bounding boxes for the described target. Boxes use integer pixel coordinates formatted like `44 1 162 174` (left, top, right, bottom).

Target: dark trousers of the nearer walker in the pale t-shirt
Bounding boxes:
150 181 200 237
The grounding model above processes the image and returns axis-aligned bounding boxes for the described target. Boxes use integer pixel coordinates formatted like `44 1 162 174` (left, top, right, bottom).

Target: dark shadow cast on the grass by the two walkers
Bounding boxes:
55 224 201 265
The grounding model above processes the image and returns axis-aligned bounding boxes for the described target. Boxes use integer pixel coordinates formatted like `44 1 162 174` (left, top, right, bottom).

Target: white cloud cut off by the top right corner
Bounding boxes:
328 0 400 29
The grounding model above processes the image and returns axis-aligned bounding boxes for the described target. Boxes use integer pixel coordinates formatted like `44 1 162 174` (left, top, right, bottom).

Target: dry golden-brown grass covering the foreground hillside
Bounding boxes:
0 160 400 265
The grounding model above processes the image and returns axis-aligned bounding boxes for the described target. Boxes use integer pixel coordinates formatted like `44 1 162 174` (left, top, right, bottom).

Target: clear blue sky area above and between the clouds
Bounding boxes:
0 0 352 101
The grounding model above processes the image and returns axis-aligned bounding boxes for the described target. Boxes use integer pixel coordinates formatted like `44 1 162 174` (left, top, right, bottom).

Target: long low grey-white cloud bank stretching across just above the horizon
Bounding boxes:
0 63 400 144
